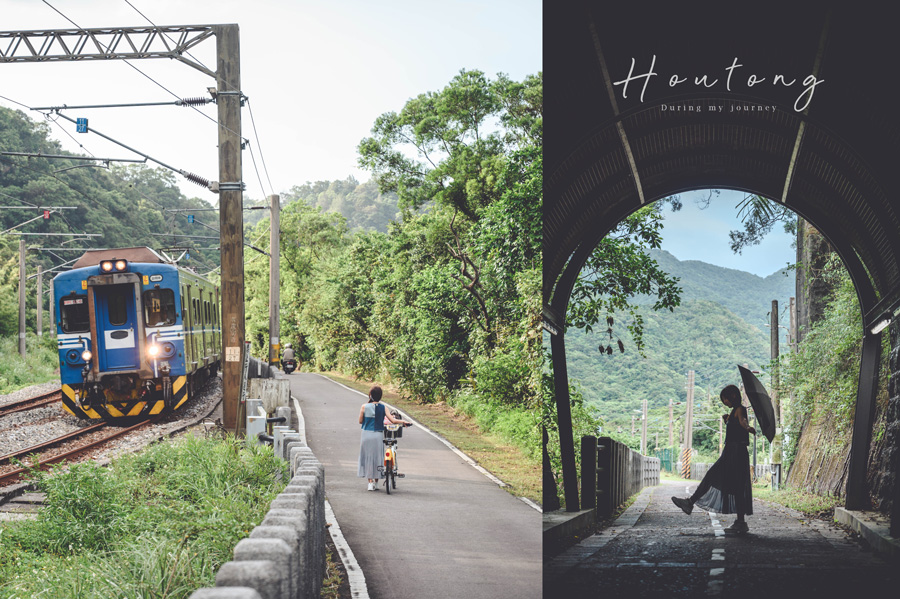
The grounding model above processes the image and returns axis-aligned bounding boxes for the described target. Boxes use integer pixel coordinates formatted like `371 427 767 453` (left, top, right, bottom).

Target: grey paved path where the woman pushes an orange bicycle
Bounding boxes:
287 373 541 599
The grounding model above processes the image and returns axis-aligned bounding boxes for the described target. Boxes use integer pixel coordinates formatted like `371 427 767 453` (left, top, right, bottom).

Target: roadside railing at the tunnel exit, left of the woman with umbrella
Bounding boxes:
581 436 660 518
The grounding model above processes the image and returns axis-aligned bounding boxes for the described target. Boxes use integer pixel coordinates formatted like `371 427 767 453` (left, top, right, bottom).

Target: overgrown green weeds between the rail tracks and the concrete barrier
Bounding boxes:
0 436 288 599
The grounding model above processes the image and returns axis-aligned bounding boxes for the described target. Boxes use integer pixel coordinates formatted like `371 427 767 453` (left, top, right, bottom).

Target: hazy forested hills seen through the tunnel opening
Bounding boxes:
566 251 794 442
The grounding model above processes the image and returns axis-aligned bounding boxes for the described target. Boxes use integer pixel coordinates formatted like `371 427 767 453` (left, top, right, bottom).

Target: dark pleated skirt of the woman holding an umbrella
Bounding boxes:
695 443 753 515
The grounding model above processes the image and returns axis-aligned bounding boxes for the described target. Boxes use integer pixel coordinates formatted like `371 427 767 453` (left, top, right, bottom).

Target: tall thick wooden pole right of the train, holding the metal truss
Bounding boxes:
213 24 244 430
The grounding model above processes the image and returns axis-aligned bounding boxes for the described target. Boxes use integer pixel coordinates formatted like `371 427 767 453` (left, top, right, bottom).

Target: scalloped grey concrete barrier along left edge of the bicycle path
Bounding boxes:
190 384 327 599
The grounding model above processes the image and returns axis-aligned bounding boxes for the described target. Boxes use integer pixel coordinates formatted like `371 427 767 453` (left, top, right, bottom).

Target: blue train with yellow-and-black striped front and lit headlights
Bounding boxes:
53 247 222 420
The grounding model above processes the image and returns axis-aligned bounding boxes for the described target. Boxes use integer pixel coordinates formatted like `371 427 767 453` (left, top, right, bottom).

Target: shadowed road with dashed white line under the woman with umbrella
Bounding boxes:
544 481 900 599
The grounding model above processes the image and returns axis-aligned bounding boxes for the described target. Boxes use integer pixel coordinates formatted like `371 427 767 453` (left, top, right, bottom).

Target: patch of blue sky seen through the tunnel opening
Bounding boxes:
662 190 796 277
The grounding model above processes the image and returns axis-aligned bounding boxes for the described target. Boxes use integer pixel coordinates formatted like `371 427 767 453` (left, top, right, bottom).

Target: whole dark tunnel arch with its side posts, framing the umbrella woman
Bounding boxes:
544 2 900 532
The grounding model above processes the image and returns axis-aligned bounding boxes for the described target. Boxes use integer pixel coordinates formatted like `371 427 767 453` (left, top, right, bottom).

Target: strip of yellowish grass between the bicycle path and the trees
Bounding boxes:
323 372 542 505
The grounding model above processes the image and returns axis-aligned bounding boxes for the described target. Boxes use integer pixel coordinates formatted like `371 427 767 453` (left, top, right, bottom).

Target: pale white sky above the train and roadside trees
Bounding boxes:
0 0 542 201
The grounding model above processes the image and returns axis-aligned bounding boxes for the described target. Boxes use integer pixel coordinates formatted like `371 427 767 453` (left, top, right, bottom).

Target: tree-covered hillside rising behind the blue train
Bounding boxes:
0 108 218 337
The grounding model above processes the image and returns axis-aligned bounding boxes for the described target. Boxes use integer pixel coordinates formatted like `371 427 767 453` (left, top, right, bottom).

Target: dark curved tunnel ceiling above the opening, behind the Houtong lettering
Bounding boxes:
544 2 900 322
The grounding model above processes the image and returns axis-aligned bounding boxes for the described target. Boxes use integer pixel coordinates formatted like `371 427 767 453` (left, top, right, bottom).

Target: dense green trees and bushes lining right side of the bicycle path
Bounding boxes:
246 71 542 454
